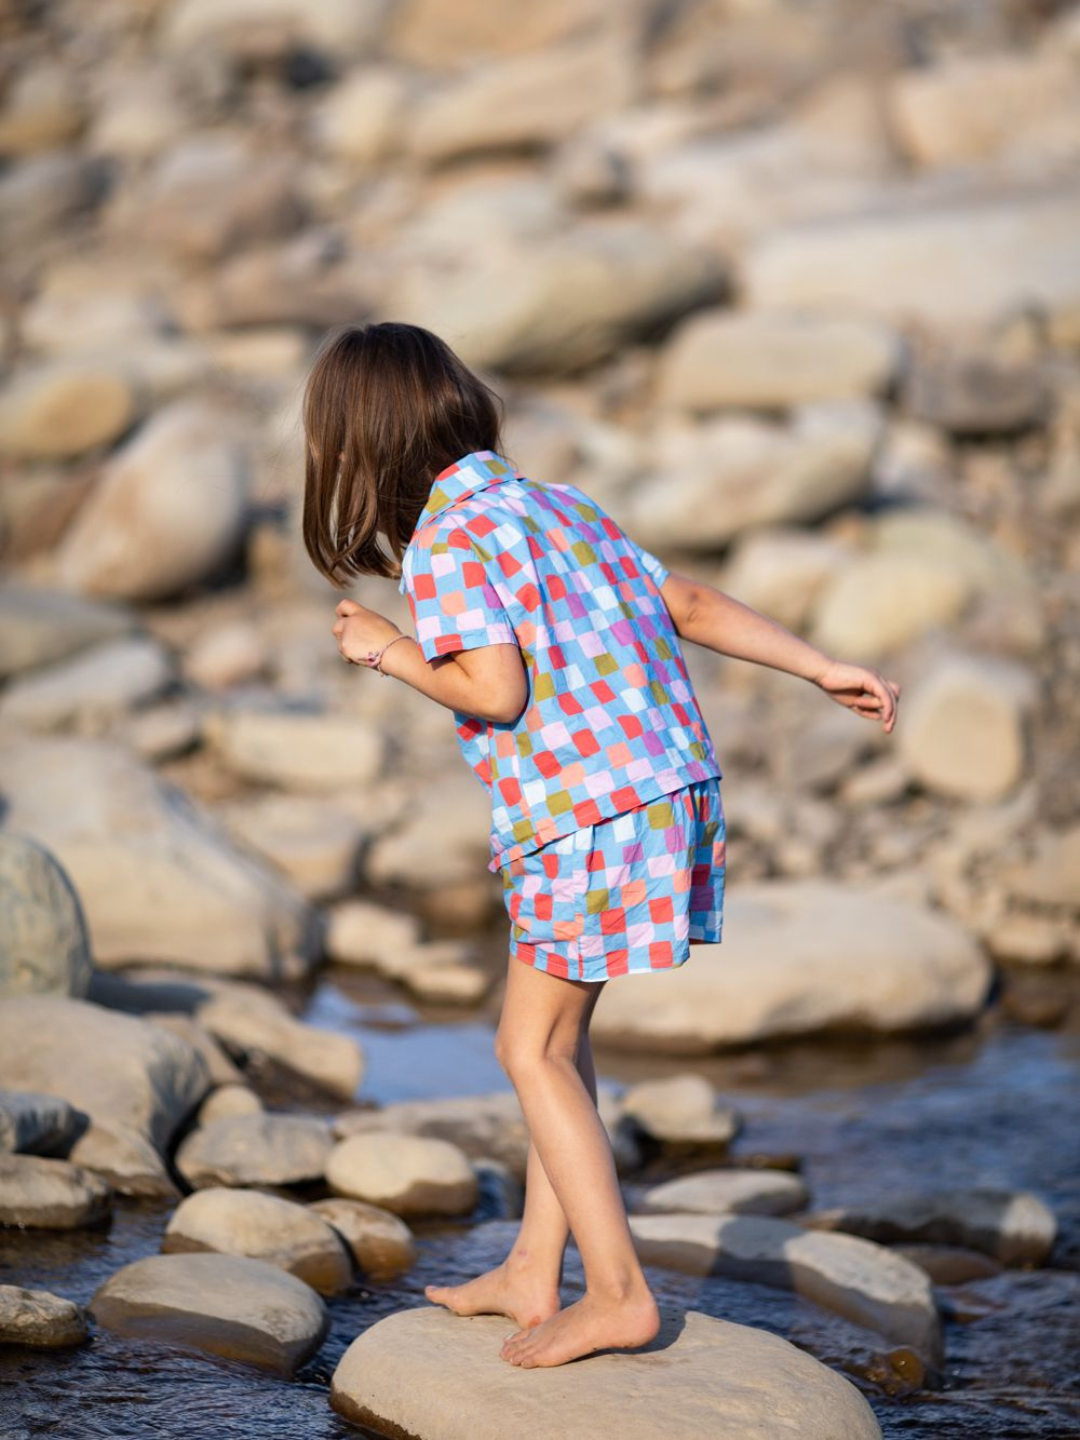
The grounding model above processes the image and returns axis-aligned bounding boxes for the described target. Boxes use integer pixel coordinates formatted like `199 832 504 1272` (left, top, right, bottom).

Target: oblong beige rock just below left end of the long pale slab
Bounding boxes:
658 308 900 412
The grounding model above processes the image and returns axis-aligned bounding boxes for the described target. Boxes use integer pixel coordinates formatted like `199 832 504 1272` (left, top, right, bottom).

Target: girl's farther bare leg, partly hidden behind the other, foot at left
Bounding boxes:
423 960 603 1328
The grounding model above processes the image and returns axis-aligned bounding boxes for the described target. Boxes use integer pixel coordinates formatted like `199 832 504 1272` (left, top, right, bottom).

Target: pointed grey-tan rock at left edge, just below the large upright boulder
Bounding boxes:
0 579 135 680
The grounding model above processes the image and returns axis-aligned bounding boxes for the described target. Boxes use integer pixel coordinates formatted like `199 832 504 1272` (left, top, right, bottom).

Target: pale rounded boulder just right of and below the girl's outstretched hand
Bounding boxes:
897 652 1037 801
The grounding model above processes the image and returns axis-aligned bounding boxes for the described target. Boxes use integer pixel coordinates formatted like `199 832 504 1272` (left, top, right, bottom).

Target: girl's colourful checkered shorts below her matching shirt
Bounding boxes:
500 776 726 981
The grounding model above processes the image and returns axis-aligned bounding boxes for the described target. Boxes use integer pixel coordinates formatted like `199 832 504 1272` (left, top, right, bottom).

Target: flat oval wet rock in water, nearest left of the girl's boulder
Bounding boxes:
91 1254 330 1375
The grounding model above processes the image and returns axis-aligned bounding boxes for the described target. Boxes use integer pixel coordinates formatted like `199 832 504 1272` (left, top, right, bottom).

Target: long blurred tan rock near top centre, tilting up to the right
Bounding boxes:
406 36 635 161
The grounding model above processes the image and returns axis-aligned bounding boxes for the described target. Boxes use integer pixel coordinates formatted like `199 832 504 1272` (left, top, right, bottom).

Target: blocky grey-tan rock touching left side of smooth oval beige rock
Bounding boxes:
176 1115 334 1189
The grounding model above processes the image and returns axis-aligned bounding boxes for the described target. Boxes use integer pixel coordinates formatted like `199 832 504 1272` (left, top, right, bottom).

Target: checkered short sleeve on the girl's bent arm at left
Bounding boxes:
399 527 517 660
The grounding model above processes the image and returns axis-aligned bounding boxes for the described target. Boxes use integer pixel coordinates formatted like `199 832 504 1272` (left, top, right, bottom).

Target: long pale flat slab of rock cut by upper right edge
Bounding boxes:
743 184 1080 330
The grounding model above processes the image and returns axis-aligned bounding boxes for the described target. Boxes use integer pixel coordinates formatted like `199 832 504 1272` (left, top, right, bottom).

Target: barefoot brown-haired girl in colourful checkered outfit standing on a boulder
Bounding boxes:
302 323 900 1367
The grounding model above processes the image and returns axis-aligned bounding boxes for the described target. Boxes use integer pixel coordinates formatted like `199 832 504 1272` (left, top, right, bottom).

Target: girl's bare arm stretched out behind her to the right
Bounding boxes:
660 573 900 734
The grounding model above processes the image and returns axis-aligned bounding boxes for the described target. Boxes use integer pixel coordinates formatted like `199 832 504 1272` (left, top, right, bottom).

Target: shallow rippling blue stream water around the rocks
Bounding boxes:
0 972 1080 1440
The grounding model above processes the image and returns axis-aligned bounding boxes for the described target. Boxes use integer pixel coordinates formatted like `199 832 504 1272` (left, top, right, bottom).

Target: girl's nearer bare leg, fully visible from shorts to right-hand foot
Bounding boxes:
495 960 660 1367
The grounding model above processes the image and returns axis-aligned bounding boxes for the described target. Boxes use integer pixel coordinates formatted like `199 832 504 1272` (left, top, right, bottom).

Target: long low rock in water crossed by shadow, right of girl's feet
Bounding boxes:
629 1214 943 1365
